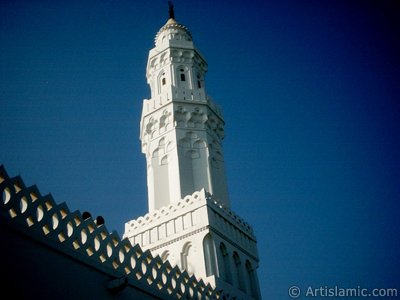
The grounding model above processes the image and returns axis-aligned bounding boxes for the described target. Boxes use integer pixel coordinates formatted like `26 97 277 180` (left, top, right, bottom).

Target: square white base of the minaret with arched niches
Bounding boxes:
124 189 258 299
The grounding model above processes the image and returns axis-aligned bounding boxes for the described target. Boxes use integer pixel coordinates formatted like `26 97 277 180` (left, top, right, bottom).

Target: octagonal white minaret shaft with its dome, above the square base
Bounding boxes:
140 18 229 211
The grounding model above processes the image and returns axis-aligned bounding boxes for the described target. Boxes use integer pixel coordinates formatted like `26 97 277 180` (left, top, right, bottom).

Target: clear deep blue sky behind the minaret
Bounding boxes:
0 0 400 299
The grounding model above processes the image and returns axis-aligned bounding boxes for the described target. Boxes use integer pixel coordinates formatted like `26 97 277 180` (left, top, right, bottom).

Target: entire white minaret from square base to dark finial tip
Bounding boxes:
124 3 260 299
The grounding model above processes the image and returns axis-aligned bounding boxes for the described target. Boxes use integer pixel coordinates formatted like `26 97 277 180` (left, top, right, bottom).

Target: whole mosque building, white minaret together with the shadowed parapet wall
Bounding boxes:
0 3 261 299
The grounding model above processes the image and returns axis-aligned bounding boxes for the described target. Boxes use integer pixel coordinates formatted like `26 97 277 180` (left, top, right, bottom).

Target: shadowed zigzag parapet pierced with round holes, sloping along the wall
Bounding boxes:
0 166 233 299
